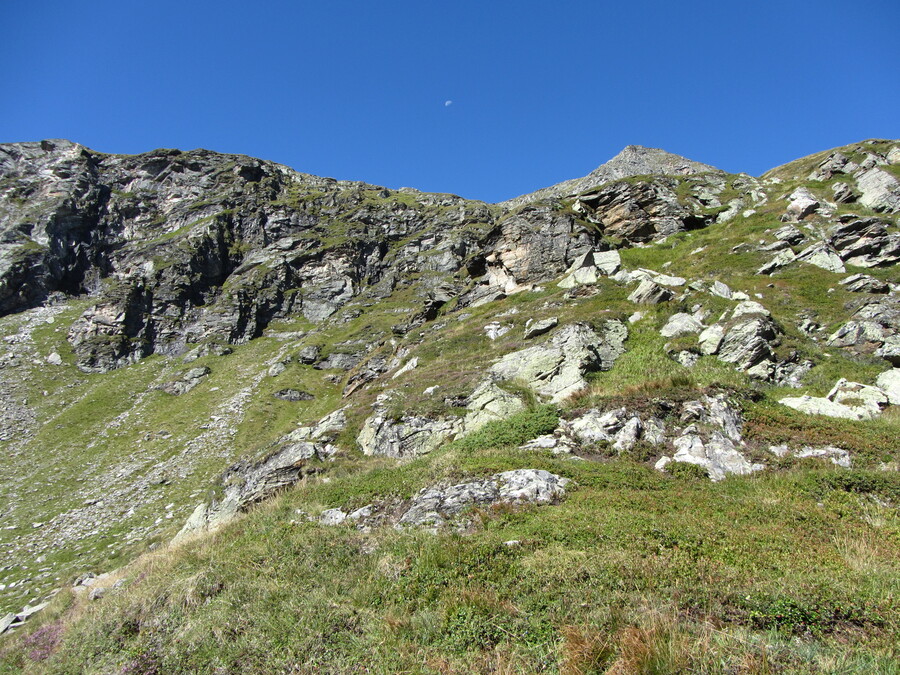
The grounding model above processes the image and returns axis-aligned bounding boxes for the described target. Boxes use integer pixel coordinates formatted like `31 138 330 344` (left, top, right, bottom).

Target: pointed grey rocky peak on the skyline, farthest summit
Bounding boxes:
503 145 722 207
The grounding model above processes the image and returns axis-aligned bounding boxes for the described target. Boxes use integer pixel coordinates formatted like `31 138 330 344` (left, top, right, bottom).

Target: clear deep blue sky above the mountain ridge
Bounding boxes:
0 0 900 201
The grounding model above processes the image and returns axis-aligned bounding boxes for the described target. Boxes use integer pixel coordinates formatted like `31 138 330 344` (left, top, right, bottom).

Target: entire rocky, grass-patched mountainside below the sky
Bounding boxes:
0 140 900 673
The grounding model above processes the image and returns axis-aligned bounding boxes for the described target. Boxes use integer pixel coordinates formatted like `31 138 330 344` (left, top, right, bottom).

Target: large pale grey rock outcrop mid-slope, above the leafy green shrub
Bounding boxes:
491 321 628 402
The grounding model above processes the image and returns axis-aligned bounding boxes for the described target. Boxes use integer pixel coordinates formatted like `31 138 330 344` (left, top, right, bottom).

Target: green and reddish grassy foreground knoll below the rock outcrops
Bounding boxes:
0 450 900 673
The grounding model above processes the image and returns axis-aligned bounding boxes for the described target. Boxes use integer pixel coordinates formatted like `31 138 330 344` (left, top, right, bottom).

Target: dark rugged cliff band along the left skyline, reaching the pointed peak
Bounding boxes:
0 141 744 371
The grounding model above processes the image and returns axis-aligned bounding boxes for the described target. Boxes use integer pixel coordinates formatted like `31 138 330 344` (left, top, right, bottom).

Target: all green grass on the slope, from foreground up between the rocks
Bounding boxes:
0 141 900 673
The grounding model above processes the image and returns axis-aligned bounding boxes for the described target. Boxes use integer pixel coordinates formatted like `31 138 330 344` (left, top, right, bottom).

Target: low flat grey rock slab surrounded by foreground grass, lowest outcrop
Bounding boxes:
397 469 570 527
